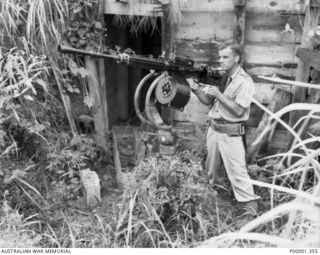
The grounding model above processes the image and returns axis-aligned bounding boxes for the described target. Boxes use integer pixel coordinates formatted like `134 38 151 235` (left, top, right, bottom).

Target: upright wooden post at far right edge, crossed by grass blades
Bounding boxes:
289 7 318 126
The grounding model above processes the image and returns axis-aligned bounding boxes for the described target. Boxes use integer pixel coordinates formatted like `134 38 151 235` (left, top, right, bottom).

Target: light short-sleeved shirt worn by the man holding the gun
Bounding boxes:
208 65 254 122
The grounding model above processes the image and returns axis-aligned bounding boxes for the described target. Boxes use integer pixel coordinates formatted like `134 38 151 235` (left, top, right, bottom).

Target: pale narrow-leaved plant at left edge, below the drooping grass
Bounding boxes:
0 45 49 160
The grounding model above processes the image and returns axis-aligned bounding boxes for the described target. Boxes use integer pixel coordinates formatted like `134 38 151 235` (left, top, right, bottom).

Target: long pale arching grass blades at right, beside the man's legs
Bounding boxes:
201 96 320 247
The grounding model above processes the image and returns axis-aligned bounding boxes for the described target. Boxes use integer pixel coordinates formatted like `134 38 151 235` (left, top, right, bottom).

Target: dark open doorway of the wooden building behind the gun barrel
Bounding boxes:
105 15 161 125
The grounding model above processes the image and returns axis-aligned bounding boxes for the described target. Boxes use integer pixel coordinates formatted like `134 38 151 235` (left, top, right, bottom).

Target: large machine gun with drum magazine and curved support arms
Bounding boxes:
58 45 222 130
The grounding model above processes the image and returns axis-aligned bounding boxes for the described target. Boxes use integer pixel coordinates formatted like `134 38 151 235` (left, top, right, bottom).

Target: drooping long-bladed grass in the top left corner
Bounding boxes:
0 0 68 52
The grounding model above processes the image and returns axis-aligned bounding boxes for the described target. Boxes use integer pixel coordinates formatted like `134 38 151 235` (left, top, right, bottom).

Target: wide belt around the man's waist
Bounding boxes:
210 119 245 136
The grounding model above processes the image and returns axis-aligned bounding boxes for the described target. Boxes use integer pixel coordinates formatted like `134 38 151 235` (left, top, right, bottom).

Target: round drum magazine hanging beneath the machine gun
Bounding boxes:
155 76 190 110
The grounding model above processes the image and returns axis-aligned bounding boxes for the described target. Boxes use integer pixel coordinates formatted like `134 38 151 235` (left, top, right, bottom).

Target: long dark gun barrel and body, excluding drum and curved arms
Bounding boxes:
58 45 219 78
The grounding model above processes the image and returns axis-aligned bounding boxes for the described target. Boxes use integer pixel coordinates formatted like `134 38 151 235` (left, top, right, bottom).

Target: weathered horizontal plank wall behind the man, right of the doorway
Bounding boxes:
174 0 305 127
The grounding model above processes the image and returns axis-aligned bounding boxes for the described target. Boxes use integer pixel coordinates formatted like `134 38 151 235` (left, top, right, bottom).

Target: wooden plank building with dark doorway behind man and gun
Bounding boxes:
97 0 316 156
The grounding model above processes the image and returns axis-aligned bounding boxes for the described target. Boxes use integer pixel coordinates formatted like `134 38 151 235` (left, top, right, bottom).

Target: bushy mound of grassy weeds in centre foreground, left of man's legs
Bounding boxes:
117 152 226 247
